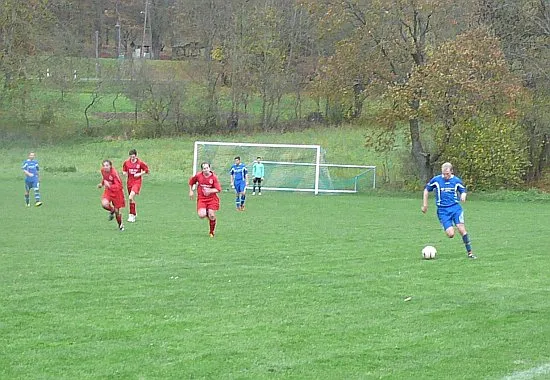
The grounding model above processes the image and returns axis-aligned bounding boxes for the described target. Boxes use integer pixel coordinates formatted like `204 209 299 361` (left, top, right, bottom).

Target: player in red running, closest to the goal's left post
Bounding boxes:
189 162 222 237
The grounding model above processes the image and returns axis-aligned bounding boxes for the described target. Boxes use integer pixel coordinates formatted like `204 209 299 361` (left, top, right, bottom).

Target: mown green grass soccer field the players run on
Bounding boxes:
0 174 550 379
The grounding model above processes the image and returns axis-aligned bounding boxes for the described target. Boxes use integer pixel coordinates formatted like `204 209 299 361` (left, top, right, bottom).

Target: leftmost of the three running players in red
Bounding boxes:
97 160 126 231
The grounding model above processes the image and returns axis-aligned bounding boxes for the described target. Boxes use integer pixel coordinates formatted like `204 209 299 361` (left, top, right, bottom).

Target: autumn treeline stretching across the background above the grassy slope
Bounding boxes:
0 0 550 188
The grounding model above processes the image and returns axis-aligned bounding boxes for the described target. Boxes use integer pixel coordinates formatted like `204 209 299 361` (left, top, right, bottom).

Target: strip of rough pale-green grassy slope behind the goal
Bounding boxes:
0 127 406 186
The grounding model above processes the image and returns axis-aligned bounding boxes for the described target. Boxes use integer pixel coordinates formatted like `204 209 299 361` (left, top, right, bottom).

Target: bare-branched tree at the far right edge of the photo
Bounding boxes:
476 0 550 180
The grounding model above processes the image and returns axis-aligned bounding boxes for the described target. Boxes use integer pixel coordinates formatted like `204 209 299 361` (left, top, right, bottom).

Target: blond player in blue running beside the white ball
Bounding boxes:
422 162 477 259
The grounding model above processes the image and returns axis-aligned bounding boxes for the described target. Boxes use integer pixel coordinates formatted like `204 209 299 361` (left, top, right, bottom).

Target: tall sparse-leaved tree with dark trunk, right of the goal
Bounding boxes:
309 0 470 178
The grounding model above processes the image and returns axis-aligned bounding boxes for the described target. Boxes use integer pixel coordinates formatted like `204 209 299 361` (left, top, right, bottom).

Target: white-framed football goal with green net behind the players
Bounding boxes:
193 141 376 194
